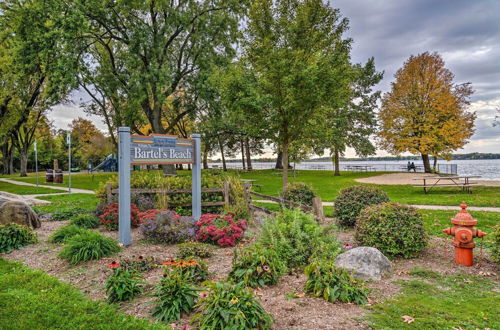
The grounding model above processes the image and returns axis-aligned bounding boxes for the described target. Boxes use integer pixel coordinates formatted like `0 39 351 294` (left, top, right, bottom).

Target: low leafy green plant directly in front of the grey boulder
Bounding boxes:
304 260 368 305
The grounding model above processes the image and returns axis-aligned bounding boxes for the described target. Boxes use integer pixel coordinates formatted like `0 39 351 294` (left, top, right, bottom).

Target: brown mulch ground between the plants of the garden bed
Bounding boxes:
2 221 498 329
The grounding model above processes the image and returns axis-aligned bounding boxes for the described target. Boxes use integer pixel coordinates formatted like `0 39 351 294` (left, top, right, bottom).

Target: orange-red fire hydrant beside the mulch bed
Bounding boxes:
443 203 486 267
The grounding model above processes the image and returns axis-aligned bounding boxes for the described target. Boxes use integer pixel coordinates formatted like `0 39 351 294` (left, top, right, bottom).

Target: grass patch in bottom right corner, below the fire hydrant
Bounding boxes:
368 268 500 329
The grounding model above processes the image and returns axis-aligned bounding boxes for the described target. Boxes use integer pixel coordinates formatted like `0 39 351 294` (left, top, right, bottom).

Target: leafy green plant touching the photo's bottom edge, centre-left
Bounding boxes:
192 282 273 330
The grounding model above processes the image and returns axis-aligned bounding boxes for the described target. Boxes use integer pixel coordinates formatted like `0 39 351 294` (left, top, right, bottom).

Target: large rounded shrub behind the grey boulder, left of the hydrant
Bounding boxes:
355 202 428 258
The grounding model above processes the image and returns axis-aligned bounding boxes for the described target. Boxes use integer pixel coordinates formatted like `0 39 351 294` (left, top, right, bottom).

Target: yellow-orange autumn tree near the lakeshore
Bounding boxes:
378 52 476 173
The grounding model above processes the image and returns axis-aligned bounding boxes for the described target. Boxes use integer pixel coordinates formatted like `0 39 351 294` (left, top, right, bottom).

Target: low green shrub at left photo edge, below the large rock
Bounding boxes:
0 223 38 253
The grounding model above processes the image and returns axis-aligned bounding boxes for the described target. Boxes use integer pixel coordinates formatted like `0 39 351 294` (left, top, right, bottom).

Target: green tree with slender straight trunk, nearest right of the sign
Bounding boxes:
245 0 350 189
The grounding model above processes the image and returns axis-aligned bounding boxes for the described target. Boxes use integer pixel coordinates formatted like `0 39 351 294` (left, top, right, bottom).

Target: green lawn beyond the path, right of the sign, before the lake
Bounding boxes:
239 170 500 206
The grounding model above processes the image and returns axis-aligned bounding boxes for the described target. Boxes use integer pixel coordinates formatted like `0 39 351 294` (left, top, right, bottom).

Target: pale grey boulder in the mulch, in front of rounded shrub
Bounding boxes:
335 246 392 281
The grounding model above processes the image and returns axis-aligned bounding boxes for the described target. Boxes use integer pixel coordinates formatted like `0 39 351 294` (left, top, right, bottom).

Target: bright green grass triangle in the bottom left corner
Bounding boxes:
0 258 168 330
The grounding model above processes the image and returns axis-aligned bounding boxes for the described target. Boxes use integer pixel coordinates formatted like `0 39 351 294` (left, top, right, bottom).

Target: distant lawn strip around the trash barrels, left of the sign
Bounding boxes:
9 172 117 190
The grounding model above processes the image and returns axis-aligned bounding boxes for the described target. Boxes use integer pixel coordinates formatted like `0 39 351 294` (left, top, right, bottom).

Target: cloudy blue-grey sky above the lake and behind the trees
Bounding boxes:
51 0 500 157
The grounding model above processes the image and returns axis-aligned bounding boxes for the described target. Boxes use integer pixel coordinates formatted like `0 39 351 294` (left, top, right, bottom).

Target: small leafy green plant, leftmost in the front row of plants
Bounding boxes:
106 267 142 303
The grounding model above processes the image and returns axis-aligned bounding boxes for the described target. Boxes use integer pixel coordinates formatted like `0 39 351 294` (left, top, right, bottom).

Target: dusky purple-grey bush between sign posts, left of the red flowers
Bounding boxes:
141 210 196 244
